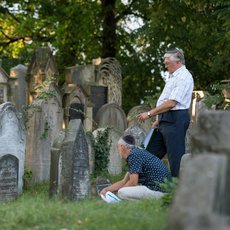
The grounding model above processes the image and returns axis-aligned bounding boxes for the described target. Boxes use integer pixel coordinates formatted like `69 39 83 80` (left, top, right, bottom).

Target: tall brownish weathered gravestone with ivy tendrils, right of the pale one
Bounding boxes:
26 85 63 183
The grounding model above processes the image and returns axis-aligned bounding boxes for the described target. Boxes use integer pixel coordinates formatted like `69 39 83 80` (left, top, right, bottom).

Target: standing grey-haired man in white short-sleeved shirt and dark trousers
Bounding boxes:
137 48 194 177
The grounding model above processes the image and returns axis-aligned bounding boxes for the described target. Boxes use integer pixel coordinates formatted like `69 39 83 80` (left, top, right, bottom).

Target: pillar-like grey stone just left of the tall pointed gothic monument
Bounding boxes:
9 65 27 111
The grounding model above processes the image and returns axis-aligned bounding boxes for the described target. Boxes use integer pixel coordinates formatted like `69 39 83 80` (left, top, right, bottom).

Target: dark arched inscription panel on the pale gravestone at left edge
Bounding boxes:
0 154 18 200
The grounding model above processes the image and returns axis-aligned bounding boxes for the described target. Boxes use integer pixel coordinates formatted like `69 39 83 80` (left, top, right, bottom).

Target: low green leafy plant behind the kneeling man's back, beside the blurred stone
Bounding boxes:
160 177 179 205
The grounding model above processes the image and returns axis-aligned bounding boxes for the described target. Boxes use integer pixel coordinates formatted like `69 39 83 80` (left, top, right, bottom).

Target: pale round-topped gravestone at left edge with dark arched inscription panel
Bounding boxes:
0 102 25 200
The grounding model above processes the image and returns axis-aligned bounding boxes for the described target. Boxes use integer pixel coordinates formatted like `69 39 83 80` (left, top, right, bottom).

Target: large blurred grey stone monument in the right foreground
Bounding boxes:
169 111 230 230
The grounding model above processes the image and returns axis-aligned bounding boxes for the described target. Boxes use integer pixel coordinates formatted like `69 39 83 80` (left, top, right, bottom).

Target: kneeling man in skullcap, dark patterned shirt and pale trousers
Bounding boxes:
100 135 171 200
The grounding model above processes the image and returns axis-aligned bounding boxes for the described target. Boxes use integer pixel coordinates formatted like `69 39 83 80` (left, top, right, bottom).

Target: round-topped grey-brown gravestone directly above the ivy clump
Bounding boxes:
96 103 127 131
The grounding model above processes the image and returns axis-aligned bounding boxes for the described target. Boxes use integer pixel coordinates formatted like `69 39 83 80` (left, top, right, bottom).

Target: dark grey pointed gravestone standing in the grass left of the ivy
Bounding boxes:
61 119 90 200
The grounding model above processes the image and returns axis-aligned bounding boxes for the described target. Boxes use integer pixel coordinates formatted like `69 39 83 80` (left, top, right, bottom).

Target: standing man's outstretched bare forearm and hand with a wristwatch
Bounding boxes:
137 100 177 121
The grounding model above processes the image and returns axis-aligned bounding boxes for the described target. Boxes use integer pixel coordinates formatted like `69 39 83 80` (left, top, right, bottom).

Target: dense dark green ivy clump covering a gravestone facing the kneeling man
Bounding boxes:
94 128 111 175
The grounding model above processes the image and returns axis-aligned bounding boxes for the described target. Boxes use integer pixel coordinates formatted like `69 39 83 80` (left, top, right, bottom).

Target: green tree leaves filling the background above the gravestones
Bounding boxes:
0 0 230 112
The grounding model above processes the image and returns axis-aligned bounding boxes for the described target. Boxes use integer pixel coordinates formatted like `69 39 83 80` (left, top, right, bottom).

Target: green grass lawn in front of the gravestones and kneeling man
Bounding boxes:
0 184 168 230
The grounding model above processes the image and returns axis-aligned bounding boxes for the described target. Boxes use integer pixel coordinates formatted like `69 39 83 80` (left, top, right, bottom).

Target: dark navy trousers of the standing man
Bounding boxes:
146 109 190 177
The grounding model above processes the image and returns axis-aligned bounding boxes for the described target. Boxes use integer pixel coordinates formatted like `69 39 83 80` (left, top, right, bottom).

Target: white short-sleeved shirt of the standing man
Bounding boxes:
157 65 194 110
